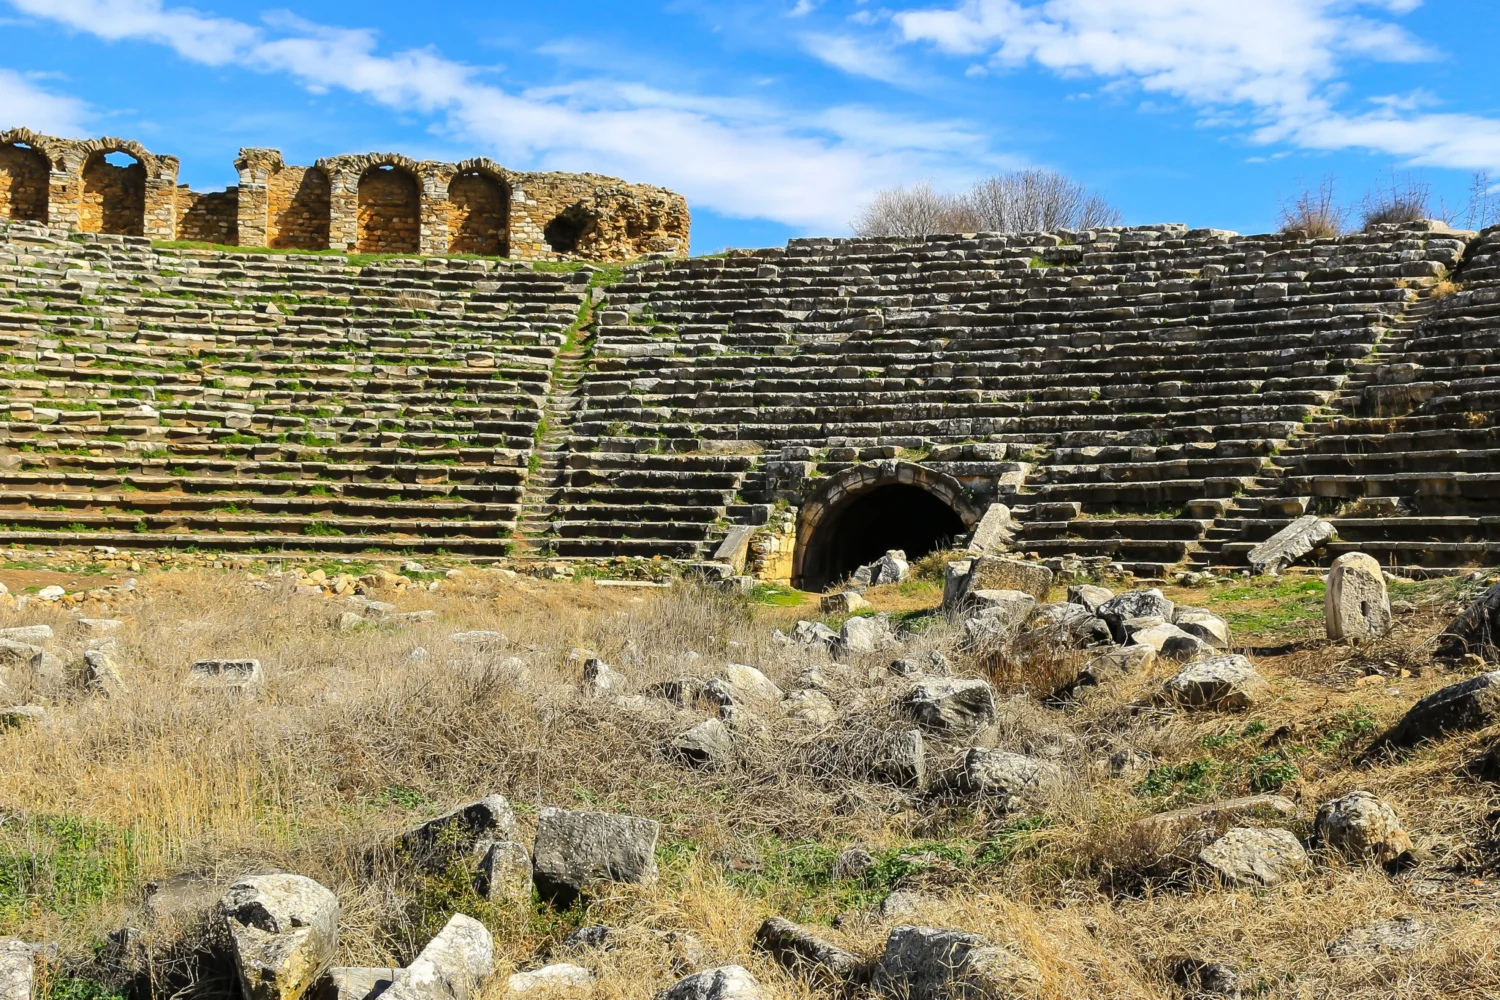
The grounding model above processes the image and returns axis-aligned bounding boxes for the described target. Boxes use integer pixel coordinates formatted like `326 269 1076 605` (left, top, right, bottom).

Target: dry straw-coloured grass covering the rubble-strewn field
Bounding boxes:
0 571 1500 1000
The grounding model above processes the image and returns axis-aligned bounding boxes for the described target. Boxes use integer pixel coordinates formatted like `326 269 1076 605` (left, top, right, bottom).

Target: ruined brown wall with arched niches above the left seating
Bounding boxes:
0 129 690 261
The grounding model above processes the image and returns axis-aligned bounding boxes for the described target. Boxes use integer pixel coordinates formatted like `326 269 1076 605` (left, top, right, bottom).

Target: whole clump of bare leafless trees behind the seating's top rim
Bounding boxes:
854 169 1122 237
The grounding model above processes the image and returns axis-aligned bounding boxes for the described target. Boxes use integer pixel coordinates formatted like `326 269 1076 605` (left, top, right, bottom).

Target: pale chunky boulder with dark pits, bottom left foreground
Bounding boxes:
219 874 339 1000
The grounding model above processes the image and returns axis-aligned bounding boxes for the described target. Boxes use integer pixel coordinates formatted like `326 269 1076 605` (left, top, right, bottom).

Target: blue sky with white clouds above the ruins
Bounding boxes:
0 0 1500 253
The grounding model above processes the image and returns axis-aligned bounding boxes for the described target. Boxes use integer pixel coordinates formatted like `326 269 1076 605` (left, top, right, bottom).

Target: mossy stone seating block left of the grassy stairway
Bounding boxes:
0 225 591 555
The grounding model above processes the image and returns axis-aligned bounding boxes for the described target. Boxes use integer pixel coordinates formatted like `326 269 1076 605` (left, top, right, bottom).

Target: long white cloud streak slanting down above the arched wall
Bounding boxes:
11 0 993 231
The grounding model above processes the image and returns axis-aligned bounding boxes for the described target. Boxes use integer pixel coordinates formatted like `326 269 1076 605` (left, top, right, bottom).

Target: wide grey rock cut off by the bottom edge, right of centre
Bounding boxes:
872 927 1041 1000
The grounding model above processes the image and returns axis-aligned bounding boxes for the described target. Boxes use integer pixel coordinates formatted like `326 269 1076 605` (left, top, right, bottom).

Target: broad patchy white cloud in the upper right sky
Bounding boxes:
893 0 1500 168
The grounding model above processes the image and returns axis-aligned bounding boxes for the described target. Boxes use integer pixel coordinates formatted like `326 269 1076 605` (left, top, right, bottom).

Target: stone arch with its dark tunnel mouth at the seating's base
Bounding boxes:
792 460 984 591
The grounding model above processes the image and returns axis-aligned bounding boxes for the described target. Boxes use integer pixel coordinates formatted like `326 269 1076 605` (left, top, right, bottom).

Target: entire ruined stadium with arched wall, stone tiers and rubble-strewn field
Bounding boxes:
0 129 1500 1000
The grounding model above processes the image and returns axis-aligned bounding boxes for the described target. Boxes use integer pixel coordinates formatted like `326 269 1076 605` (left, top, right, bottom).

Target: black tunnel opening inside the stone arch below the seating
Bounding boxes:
798 483 969 591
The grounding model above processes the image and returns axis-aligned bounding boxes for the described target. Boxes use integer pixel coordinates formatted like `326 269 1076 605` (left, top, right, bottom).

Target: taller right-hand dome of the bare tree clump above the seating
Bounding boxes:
959 169 1121 232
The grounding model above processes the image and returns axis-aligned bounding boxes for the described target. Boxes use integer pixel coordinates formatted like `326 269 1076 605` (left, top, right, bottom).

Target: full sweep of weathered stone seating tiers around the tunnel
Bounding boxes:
0 212 1500 588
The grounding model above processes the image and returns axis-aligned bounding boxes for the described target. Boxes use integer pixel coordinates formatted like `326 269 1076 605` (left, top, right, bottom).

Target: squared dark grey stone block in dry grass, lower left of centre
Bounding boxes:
531 808 662 904
